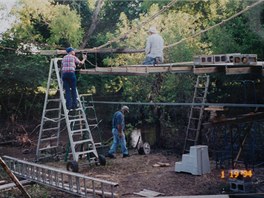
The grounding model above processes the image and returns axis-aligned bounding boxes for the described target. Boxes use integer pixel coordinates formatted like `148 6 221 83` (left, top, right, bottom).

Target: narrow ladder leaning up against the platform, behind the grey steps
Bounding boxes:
183 75 209 153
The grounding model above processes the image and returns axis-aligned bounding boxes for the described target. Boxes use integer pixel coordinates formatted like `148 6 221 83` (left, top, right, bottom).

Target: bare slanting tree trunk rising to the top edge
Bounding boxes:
80 0 104 49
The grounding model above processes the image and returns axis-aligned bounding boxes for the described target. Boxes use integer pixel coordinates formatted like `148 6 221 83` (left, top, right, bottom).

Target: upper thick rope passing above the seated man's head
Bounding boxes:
95 0 178 49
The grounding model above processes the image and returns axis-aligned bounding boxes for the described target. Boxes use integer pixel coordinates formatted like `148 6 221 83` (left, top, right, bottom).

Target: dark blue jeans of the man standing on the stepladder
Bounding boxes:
62 72 77 109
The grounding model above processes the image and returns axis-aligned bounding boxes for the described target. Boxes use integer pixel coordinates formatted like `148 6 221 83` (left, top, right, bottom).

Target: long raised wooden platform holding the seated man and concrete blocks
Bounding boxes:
80 62 264 76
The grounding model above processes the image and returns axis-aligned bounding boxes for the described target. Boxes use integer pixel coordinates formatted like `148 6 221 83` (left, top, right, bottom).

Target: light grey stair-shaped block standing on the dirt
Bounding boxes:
175 145 211 175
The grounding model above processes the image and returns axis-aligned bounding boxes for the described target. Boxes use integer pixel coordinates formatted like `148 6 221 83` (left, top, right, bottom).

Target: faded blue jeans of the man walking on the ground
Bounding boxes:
108 128 128 155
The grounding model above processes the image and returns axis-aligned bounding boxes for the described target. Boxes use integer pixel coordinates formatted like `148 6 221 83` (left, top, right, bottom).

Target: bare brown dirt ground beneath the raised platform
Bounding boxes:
0 143 264 198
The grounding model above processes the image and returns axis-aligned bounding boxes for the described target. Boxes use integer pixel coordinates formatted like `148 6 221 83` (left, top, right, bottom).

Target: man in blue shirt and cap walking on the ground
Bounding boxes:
107 106 129 158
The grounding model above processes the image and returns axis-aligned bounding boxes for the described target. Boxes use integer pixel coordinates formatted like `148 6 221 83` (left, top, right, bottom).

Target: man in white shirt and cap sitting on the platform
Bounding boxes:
143 27 164 65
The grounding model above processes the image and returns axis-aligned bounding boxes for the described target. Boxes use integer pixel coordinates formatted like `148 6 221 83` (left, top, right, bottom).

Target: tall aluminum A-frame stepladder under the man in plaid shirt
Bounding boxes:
36 58 102 172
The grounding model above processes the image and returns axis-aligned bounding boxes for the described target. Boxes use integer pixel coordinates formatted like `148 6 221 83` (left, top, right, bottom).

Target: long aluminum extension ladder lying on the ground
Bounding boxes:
3 156 118 197
